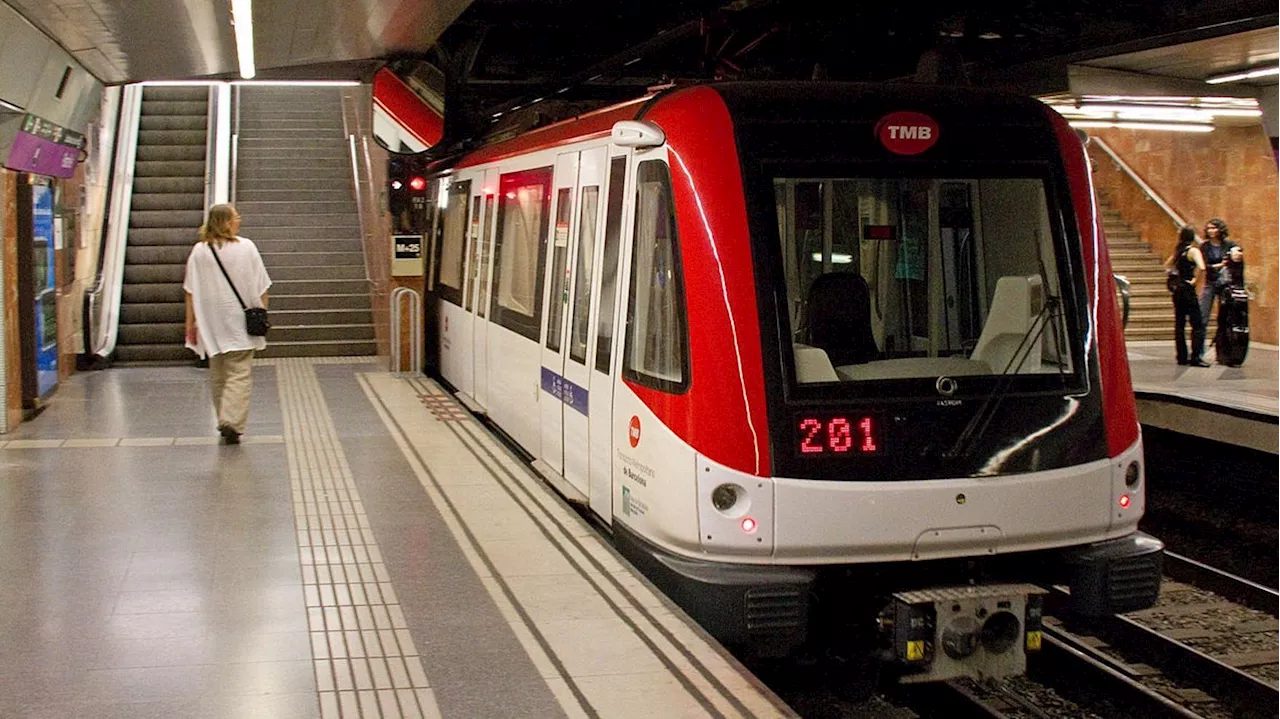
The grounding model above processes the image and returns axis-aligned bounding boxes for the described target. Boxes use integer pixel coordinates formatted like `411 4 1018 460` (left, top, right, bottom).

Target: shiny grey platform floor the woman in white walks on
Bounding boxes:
0 358 795 719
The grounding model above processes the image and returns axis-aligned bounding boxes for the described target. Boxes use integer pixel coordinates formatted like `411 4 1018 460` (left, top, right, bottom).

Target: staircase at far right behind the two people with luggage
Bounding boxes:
1098 197 1217 347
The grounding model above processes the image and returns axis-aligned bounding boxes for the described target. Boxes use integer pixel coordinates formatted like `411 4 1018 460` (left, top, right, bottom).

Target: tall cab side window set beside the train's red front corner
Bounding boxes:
623 160 689 393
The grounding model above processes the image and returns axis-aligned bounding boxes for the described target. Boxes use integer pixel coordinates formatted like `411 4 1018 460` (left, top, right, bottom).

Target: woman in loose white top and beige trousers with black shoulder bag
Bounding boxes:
182 205 271 444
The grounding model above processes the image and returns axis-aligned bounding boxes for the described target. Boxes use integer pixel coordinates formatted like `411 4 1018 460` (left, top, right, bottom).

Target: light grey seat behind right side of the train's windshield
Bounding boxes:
969 275 1044 375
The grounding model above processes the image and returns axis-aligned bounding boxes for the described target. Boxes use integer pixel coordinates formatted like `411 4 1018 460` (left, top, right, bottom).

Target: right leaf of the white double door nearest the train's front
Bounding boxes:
561 147 608 496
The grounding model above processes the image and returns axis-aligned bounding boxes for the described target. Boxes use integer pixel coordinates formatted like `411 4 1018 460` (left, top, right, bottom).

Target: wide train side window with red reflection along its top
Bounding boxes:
489 168 552 342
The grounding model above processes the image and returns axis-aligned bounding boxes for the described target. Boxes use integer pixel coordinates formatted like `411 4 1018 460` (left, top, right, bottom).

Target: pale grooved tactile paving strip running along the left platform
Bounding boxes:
271 358 440 719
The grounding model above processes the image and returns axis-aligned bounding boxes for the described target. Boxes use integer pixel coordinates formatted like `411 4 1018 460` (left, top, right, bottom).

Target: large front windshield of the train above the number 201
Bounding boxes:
773 177 1078 388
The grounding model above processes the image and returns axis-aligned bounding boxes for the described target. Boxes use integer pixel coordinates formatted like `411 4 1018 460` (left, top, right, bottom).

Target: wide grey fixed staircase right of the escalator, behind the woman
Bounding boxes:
236 87 378 357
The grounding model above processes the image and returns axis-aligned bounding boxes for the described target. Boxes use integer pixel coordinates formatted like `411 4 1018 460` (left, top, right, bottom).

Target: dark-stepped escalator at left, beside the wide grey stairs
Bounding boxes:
115 87 209 363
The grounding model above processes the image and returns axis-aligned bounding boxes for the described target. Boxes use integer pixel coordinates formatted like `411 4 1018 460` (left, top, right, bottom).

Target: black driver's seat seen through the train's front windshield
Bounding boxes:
804 273 879 367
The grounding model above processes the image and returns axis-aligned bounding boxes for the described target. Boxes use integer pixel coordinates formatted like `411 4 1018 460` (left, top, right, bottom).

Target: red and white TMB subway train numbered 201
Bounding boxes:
417 82 1164 681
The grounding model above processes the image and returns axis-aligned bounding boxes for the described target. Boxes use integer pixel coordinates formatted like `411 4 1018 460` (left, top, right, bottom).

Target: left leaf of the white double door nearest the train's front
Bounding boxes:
538 152 582 491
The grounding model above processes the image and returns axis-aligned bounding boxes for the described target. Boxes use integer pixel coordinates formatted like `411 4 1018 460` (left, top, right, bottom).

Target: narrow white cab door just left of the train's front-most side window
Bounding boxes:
586 148 627 521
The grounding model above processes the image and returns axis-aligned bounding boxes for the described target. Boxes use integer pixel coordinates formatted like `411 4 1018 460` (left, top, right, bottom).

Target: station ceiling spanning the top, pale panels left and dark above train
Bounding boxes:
0 0 1280 102
